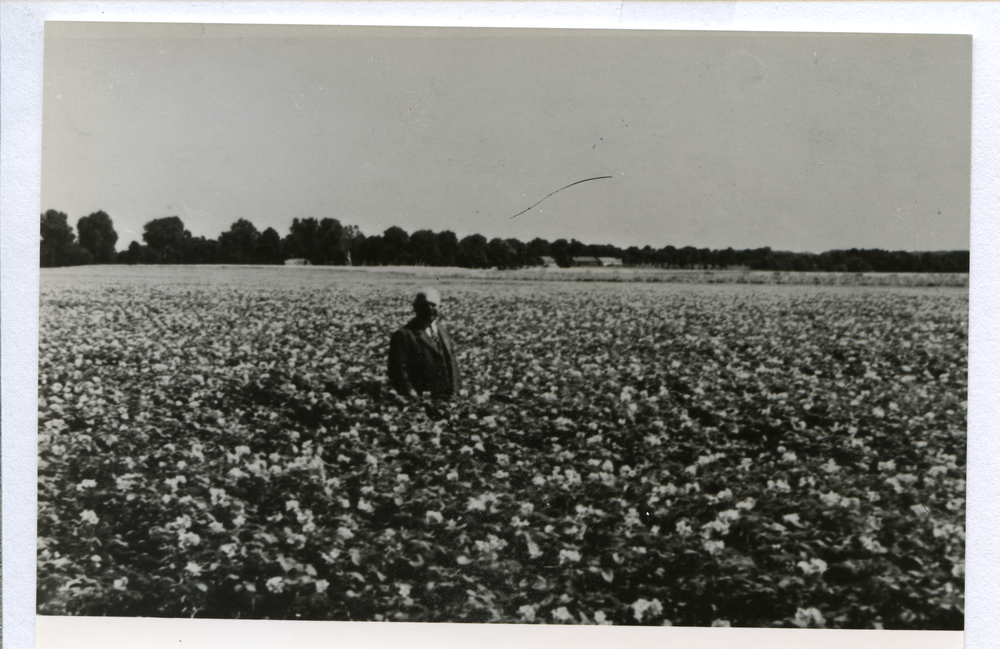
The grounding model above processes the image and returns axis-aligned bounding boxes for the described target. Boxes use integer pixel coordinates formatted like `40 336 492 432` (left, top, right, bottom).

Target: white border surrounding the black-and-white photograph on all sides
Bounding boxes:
0 0 1000 649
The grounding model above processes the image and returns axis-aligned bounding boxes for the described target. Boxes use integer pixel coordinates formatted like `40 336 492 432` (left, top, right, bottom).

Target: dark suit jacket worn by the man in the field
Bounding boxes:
389 318 462 397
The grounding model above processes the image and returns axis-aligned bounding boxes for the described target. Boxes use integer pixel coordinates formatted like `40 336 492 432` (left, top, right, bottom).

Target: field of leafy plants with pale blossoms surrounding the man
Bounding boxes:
37 268 968 629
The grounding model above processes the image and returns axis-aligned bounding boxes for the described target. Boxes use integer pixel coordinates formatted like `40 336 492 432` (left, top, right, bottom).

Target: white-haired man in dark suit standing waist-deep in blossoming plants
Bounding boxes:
389 288 461 398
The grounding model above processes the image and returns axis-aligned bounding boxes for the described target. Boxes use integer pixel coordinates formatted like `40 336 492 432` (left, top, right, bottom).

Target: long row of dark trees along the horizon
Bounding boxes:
39 210 969 273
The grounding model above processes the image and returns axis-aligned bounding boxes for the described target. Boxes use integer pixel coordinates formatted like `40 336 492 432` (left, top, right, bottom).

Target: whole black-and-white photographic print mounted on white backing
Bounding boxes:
32 21 973 631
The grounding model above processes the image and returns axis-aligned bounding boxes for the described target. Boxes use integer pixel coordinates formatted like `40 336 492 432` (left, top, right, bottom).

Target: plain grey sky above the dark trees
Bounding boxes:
41 23 972 252
